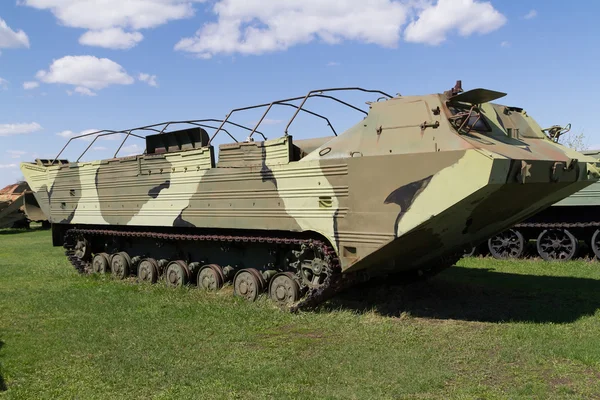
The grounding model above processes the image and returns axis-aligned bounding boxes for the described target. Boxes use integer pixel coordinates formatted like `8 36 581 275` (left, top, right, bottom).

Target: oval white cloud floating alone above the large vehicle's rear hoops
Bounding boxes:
36 56 134 92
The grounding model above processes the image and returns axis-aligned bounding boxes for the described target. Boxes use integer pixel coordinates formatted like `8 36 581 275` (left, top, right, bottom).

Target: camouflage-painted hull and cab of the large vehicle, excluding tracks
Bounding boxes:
21 87 598 271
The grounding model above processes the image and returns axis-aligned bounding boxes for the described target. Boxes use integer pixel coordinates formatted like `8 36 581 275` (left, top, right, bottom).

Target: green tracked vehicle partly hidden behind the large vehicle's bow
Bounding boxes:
480 150 600 261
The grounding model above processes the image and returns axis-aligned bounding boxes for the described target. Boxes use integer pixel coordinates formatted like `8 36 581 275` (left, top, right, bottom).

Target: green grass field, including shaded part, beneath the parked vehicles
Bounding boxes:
0 230 600 399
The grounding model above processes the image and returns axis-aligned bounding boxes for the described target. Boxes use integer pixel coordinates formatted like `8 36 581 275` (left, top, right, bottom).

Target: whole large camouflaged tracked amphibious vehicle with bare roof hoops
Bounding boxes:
21 81 598 307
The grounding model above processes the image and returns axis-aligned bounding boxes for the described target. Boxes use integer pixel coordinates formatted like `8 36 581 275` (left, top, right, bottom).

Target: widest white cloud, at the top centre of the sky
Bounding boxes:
175 0 409 58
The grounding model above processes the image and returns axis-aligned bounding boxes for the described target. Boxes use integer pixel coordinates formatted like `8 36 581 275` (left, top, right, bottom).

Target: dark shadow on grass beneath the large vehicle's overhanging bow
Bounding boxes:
320 266 600 324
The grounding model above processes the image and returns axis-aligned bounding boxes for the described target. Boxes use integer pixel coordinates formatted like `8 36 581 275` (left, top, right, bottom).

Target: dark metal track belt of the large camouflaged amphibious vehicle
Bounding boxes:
63 228 344 312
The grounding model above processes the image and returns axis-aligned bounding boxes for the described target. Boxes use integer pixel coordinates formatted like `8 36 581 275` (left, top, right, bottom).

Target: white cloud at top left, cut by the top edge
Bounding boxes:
19 0 205 49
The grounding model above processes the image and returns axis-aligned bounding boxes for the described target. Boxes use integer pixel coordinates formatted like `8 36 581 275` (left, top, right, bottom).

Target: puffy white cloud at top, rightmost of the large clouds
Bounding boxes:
404 0 506 45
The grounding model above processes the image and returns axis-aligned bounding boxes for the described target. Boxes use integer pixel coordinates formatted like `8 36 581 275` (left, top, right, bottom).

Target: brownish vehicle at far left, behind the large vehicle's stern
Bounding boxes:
0 182 47 229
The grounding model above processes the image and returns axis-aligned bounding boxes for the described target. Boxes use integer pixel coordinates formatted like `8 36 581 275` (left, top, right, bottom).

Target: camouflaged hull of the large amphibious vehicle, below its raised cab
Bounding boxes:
22 149 591 273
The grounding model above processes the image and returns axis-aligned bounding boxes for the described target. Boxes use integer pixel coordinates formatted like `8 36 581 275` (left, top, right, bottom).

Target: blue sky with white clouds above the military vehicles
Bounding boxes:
0 0 600 187
